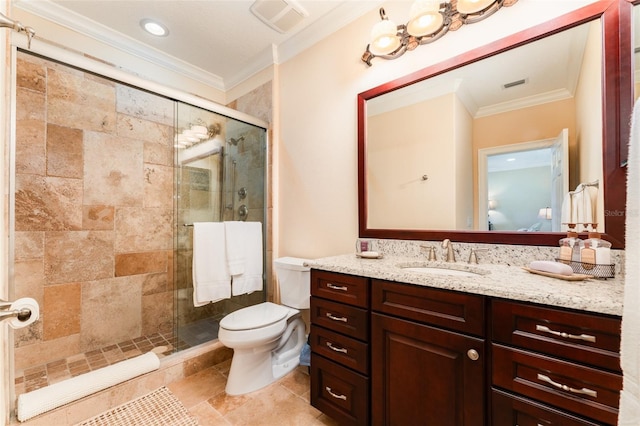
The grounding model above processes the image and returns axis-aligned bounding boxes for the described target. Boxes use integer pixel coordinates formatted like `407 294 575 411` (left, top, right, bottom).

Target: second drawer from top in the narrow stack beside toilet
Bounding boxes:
311 296 369 341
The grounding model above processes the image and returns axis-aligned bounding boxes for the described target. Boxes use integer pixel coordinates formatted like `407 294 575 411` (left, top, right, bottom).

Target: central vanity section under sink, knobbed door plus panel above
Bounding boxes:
371 280 486 426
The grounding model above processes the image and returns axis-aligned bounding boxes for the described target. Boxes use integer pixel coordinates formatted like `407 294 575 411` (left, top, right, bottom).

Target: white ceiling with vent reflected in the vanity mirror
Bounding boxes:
367 22 601 118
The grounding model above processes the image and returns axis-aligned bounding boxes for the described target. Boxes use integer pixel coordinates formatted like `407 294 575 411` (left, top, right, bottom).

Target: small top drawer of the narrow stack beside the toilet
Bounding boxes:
311 269 369 308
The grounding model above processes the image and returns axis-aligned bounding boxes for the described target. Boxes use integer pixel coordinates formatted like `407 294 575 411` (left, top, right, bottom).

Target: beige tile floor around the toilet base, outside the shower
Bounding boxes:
167 360 338 426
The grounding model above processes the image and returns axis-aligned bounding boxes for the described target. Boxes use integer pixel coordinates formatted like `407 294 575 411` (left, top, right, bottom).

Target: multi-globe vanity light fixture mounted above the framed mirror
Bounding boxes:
362 0 518 66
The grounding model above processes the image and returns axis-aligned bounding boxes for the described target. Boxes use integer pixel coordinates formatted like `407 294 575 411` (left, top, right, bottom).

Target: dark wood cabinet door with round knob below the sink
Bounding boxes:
371 313 485 426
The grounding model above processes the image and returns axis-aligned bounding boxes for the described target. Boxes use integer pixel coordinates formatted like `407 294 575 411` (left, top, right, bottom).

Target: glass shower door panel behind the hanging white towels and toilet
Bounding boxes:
174 102 266 350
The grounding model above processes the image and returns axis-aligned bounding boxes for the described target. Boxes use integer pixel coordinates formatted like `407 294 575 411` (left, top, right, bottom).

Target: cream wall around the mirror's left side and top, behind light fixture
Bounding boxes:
276 1 591 257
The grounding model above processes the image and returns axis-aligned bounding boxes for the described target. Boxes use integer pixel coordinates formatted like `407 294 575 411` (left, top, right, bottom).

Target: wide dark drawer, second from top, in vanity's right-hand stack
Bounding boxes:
492 344 622 425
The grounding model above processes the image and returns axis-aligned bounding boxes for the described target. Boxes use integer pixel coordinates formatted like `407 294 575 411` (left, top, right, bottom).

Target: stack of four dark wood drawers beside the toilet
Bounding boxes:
309 270 371 425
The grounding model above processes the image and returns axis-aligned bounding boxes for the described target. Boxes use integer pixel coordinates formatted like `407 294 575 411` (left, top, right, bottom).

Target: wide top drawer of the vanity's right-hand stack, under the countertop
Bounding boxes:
492 300 621 371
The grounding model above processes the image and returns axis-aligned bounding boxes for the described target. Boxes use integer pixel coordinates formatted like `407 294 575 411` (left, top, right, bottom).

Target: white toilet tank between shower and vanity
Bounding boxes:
273 257 311 309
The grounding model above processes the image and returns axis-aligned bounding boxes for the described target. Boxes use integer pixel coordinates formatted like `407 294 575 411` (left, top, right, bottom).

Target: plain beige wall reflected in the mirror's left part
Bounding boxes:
367 94 457 229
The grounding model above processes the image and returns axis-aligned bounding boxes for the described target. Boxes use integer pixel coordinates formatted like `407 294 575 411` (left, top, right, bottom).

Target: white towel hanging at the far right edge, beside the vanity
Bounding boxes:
618 100 640 426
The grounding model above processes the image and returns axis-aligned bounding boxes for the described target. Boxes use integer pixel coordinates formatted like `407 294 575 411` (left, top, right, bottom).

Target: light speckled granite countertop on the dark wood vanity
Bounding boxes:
305 254 624 316
